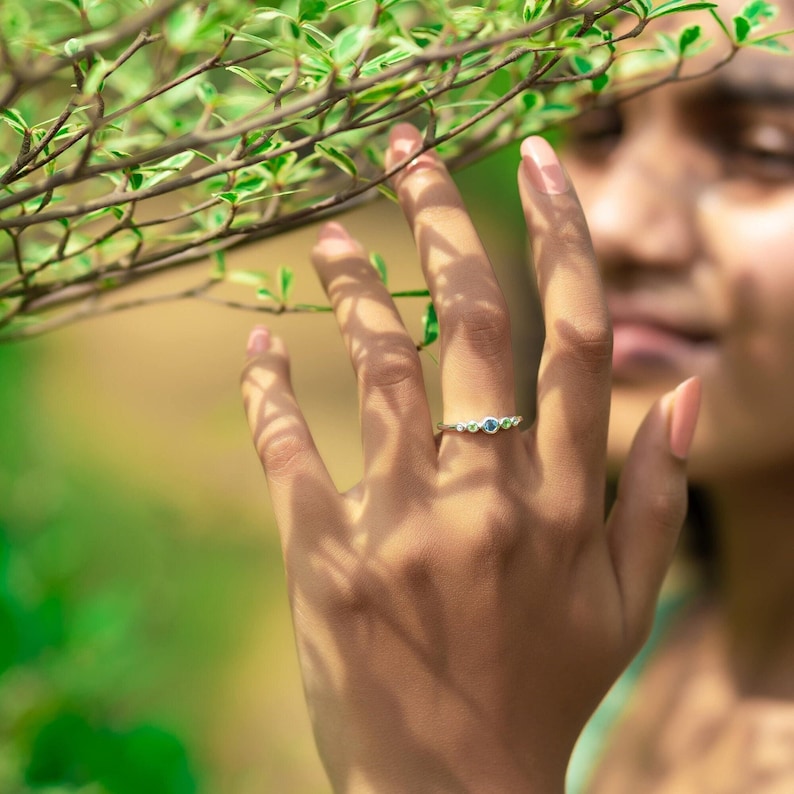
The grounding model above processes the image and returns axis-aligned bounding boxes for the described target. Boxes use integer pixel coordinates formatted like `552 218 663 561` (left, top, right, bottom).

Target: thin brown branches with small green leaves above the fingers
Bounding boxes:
0 0 785 339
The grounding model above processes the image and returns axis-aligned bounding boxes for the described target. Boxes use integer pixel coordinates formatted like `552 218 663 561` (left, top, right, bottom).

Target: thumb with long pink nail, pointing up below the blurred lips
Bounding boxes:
607 378 700 643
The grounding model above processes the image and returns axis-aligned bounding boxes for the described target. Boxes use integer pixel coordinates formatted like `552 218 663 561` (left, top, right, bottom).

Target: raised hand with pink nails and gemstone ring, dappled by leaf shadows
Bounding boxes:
243 120 699 794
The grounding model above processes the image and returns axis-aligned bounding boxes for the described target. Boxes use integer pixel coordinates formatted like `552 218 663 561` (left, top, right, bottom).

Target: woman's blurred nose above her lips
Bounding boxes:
585 127 707 270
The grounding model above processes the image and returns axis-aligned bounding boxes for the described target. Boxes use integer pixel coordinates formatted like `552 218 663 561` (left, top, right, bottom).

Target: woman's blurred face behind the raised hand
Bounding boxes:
566 3 794 482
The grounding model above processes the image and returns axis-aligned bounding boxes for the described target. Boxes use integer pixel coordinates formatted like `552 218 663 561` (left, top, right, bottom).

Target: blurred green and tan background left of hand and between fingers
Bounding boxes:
0 148 539 794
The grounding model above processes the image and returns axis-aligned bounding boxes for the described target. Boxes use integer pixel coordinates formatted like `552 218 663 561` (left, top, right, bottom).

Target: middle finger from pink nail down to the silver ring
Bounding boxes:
387 124 515 424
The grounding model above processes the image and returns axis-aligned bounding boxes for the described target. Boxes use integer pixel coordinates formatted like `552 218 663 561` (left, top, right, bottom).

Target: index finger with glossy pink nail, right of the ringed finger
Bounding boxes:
518 138 612 488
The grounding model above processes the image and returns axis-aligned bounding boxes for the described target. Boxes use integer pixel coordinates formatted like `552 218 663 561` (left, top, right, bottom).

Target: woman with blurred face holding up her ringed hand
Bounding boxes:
238 4 794 794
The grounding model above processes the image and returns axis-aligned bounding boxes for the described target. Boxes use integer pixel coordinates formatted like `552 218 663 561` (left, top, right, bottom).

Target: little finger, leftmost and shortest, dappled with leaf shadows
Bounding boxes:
241 326 341 552
